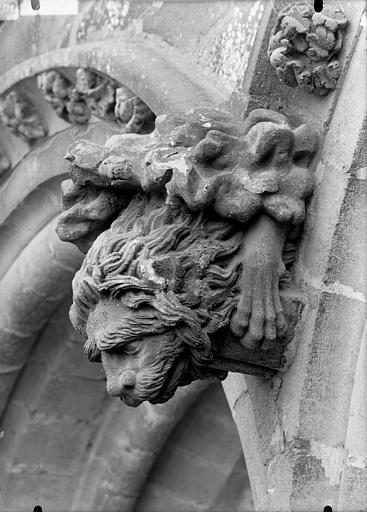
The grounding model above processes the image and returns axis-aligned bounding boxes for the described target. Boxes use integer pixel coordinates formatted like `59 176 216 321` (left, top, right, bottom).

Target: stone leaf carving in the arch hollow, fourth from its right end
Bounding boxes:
0 91 47 144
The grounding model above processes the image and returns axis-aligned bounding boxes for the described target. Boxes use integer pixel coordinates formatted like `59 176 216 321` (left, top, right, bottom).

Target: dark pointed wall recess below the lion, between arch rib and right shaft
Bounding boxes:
135 384 253 512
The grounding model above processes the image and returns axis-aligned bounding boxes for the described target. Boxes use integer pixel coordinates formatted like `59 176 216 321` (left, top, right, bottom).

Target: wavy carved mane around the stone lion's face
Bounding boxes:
70 194 243 388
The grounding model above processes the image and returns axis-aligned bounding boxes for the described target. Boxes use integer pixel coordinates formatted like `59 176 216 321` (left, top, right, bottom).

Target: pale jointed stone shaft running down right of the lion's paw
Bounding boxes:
223 8 367 512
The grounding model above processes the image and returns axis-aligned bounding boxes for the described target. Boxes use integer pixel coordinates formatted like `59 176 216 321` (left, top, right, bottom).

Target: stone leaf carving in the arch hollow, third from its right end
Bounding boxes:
37 70 91 124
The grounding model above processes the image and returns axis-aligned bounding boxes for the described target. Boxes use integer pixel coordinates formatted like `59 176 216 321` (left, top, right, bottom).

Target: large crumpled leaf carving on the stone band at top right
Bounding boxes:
268 3 348 95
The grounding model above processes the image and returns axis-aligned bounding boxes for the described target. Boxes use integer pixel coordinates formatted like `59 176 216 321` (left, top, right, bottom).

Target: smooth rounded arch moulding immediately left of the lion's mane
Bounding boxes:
0 224 81 415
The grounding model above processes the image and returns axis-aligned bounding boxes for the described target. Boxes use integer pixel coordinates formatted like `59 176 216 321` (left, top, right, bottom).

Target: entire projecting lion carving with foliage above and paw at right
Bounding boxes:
57 109 317 406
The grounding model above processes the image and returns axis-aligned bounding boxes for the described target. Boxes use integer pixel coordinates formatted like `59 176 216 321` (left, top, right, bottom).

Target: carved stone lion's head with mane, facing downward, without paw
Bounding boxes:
70 195 242 405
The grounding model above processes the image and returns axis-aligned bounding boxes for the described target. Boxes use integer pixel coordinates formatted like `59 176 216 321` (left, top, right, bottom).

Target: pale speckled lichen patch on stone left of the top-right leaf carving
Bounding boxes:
204 0 264 90
